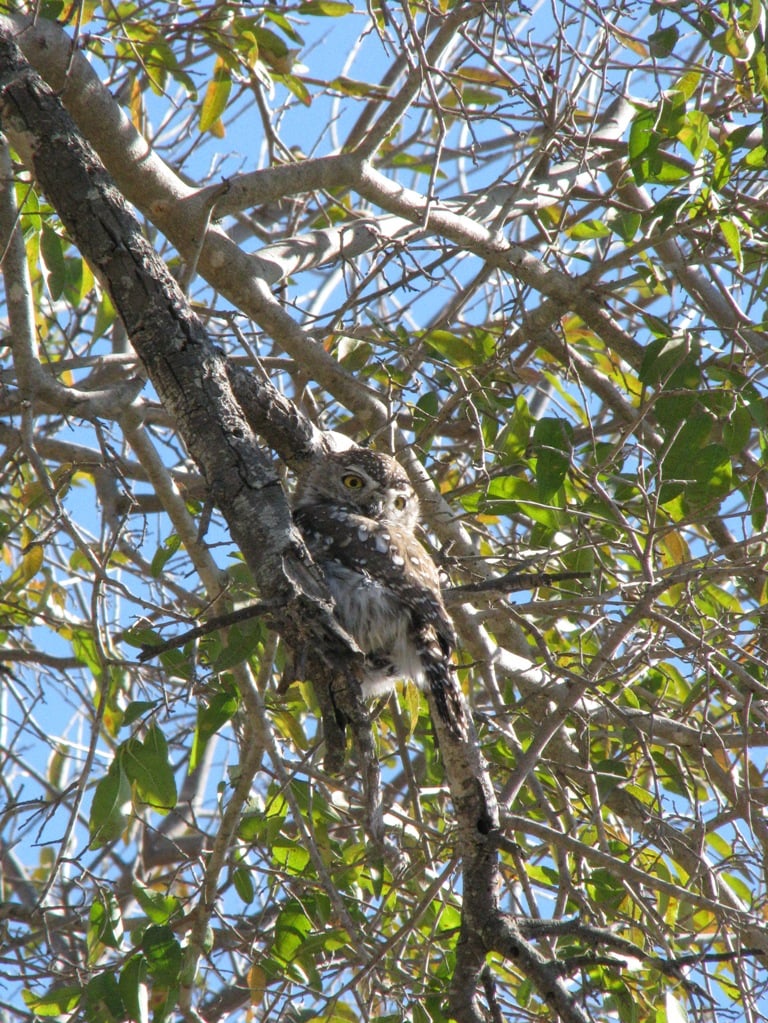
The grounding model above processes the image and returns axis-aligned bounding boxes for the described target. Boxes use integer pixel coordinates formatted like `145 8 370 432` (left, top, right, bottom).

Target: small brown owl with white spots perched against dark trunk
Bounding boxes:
293 448 467 738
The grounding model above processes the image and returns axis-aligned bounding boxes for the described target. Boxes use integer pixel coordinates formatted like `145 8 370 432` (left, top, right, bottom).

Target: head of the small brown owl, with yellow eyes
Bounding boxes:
295 448 418 528
